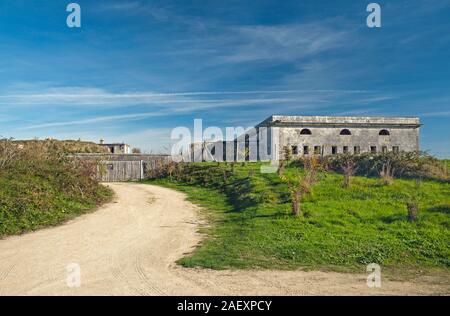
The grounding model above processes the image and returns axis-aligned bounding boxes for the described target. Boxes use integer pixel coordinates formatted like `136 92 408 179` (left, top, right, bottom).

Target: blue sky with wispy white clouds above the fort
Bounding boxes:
0 0 450 158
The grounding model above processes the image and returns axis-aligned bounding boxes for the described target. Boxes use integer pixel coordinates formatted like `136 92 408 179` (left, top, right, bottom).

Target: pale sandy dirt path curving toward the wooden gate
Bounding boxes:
0 184 448 295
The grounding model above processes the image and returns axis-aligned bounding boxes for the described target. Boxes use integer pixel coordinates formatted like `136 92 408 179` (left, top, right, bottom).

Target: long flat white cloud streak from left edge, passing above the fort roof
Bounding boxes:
0 87 370 109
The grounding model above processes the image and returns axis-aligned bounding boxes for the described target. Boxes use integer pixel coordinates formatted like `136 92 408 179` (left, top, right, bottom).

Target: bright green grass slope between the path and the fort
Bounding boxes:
146 163 450 271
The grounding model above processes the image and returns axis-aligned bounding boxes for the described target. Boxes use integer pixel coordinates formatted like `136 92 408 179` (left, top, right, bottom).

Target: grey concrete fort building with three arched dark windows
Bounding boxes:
199 115 421 161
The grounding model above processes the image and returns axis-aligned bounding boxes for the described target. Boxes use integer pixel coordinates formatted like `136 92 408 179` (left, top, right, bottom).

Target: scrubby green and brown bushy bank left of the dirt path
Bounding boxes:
0 140 112 237
